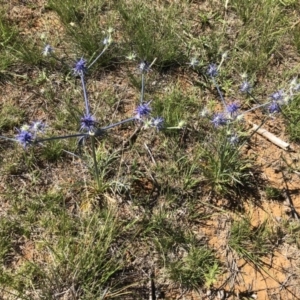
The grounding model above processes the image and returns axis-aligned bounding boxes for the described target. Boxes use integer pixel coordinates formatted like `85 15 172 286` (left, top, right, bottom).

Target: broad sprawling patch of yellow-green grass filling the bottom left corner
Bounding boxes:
1 197 134 299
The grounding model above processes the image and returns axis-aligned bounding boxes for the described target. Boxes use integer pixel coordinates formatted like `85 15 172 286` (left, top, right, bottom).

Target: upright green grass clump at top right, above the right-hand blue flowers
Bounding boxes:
231 0 288 74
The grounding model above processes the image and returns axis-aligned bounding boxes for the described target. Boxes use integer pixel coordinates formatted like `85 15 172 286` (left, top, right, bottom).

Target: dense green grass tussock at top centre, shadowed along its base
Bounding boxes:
118 1 184 68
